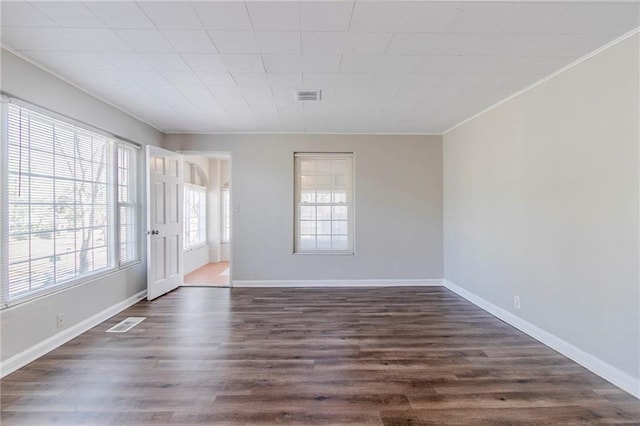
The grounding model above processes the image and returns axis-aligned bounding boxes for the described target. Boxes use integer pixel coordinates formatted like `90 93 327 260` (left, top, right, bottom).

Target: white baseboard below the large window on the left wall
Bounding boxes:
0 290 147 377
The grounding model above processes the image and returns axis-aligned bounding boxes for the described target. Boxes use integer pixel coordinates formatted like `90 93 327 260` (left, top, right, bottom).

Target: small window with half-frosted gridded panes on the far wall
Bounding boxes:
294 153 353 254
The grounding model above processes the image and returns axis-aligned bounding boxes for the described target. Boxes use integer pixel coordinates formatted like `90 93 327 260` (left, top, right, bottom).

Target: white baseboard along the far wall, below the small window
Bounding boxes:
231 279 442 288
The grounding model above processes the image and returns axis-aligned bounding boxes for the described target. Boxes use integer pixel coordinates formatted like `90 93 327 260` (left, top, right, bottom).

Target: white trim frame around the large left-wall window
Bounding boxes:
0 98 142 310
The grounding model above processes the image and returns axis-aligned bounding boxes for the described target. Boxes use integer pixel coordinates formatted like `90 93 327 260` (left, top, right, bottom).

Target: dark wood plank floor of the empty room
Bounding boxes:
1 287 640 426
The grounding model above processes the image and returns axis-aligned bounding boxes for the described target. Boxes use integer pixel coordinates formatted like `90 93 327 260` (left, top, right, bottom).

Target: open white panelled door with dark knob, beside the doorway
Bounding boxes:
147 145 184 300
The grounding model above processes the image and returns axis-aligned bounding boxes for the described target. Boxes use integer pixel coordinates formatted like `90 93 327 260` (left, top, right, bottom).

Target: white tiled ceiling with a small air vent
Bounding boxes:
1 0 640 133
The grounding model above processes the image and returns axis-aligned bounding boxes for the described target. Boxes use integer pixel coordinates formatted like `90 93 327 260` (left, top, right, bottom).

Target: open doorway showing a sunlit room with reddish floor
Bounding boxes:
182 152 231 287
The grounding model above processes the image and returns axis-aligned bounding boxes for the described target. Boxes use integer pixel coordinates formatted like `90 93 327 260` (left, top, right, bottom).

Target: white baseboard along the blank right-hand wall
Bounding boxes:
443 280 640 399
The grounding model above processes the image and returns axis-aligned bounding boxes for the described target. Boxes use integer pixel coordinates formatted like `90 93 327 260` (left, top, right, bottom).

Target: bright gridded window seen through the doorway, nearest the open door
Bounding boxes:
184 183 207 250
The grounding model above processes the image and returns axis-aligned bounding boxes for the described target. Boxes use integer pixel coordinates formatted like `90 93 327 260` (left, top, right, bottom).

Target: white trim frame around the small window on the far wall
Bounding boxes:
293 152 356 256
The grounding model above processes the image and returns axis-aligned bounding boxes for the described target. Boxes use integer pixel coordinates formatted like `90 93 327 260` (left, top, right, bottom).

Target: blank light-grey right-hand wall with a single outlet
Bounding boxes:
443 35 640 382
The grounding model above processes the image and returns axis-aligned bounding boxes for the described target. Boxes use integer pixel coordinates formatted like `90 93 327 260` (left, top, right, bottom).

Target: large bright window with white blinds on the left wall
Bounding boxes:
2 103 138 304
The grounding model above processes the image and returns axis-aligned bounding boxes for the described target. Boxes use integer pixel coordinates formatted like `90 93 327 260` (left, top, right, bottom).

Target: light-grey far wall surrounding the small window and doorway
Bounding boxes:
164 135 442 282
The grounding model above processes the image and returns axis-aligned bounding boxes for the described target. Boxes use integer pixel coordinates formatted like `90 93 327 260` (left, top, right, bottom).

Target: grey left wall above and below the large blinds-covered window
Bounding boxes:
0 49 161 363
